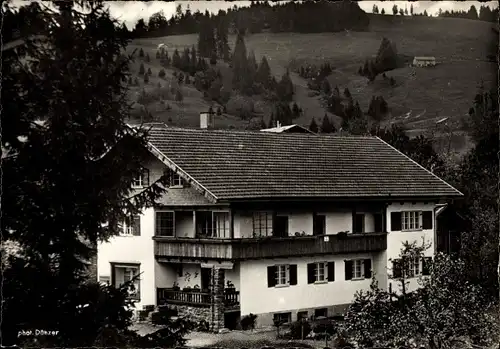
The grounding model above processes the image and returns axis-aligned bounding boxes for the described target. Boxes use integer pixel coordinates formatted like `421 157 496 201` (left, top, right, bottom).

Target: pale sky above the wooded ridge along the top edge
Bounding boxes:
13 0 498 29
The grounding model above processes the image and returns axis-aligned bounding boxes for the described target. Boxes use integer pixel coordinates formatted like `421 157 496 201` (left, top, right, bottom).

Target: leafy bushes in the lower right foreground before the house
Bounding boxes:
346 254 496 349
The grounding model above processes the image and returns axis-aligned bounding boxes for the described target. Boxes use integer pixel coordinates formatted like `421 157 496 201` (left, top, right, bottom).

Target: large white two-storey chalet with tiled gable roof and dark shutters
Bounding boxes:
97 121 462 331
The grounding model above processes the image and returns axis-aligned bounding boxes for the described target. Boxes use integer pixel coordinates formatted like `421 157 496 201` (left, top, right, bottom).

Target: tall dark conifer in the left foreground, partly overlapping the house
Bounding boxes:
1 1 180 347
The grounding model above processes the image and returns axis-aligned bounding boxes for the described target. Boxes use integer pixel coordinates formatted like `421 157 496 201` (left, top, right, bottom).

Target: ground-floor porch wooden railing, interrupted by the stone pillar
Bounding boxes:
156 288 240 310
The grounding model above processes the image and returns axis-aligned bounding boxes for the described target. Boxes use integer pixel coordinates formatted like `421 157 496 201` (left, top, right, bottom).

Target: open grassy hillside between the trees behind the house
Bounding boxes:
130 15 498 152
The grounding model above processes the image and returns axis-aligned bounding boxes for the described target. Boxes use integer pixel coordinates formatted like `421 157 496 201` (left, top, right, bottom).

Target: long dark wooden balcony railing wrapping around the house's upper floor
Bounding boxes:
153 233 387 260
